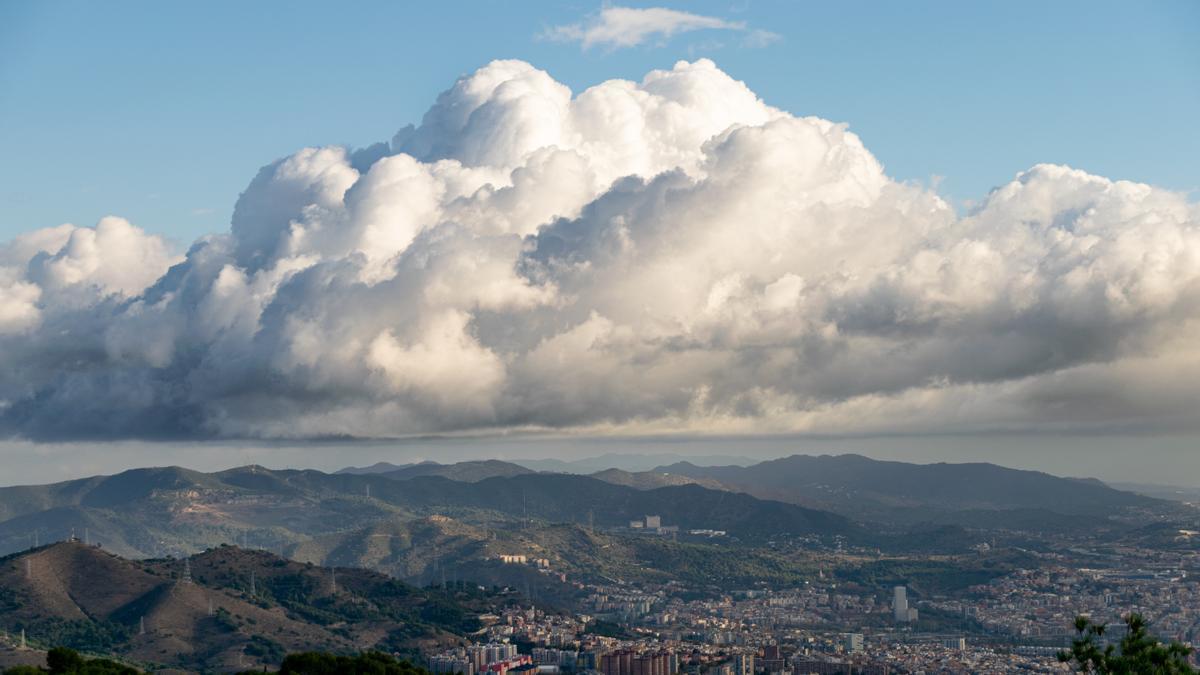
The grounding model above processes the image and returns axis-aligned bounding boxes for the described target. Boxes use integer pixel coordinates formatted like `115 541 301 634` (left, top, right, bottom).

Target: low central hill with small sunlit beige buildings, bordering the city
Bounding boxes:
287 516 817 590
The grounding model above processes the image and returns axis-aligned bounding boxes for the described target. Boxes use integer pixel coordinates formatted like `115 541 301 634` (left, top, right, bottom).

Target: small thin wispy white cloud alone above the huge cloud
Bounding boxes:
542 6 779 49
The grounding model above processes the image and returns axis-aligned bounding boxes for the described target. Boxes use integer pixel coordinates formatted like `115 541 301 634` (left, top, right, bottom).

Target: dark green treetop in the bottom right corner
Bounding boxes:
1058 614 1196 675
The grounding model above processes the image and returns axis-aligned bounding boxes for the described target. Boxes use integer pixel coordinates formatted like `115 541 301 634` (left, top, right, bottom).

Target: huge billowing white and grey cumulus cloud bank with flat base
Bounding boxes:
0 60 1200 440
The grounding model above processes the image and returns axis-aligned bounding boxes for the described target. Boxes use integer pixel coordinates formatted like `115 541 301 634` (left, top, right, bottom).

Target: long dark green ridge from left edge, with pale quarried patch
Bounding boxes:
0 462 856 557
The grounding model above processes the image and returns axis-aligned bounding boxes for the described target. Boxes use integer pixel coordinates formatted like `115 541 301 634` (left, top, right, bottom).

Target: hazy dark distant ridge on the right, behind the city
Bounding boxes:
655 455 1175 524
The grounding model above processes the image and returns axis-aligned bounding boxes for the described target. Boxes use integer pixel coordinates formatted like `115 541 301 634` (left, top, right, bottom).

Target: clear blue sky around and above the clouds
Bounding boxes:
0 0 1200 247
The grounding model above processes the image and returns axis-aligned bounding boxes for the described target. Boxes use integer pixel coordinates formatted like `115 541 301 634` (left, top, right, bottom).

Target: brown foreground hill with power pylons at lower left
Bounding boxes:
0 542 493 670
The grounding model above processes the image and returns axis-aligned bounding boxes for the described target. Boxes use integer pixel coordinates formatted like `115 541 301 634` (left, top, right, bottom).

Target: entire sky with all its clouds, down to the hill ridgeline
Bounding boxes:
0 1 1200 483
